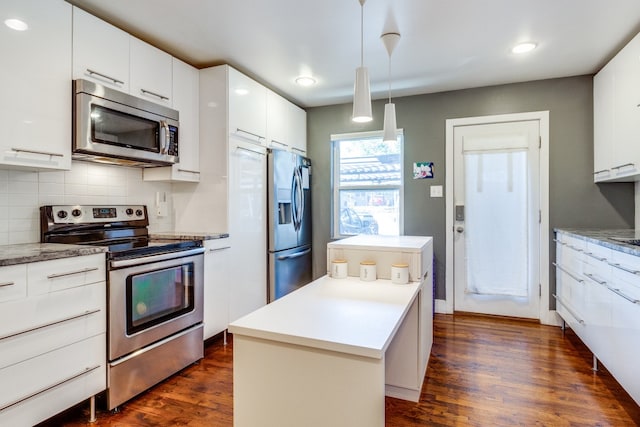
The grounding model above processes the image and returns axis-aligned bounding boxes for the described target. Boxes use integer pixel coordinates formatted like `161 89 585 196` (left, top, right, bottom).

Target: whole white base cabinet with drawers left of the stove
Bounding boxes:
0 254 106 426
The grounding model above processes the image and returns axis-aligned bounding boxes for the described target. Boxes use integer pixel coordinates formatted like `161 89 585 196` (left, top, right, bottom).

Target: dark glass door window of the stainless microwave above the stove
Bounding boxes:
91 105 160 153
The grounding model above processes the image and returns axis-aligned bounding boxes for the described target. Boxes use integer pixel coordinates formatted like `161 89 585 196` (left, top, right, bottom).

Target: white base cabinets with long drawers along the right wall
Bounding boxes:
556 231 640 404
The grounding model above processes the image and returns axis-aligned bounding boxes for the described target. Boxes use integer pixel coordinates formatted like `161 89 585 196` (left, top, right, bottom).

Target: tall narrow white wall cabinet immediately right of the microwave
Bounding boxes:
143 58 200 182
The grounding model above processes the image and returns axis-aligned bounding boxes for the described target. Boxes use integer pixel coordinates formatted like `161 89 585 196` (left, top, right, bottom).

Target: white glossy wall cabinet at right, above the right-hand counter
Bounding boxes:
593 34 640 182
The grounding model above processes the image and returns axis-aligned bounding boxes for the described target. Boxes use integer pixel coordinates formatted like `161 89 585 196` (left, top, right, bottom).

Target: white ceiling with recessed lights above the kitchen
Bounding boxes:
67 0 640 107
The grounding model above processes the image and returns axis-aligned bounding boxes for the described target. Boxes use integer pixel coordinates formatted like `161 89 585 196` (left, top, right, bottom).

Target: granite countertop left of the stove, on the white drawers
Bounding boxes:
0 243 108 267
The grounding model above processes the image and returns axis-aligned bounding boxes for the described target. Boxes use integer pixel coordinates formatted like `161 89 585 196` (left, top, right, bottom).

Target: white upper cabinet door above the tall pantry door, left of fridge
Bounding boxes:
228 67 267 145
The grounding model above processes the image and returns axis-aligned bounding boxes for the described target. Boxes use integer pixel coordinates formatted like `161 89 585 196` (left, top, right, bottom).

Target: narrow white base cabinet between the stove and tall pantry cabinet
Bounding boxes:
204 238 231 340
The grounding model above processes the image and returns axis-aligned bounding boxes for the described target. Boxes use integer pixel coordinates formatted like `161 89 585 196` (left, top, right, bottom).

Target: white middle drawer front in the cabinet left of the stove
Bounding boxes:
0 281 106 337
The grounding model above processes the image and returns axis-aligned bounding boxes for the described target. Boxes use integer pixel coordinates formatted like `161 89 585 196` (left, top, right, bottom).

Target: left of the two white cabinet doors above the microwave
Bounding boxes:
73 7 130 93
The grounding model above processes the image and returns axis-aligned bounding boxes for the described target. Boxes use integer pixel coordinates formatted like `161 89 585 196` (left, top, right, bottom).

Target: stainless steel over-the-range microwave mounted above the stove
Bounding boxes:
72 79 179 167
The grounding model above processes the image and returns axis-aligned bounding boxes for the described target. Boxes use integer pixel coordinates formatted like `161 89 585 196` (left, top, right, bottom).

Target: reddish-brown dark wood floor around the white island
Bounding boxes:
37 314 640 427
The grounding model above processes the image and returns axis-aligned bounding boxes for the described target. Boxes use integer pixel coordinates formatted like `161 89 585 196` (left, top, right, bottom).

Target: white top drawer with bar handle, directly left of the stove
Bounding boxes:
27 254 106 296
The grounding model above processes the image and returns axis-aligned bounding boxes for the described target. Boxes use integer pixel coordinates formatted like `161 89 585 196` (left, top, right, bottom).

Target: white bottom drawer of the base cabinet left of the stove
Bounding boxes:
0 334 106 417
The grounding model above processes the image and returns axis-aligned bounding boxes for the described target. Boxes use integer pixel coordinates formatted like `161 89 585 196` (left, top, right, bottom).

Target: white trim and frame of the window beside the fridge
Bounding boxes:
329 129 405 239
